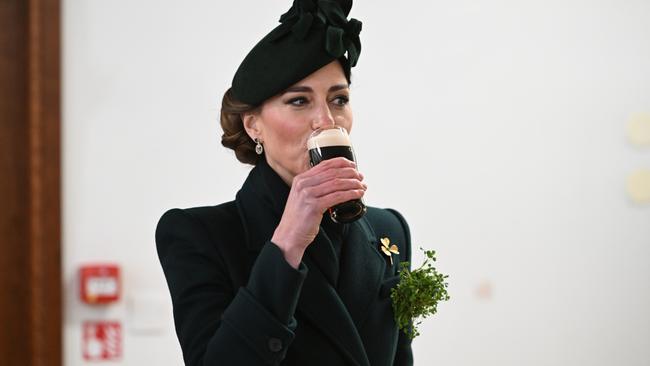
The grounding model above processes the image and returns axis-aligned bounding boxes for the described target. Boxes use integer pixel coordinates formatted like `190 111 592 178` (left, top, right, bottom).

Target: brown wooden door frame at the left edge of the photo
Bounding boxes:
0 0 63 366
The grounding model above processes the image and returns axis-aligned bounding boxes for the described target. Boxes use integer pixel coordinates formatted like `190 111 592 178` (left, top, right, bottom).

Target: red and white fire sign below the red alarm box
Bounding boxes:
82 321 122 361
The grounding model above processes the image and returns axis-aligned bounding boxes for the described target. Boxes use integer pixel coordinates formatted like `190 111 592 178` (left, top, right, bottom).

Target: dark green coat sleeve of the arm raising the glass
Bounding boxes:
156 209 307 366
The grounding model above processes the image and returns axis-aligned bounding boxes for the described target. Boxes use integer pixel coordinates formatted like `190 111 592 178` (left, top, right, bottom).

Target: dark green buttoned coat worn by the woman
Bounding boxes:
156 159 413 366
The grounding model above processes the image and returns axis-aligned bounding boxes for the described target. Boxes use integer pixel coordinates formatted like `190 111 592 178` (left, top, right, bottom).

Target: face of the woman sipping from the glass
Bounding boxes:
244 61 352 185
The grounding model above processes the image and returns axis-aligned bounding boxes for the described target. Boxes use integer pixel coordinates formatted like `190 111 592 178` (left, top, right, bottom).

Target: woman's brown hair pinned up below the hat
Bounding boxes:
221 88 264 165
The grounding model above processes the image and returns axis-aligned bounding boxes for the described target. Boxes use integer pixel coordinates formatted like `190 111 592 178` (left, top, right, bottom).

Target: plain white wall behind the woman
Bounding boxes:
63 0 650 366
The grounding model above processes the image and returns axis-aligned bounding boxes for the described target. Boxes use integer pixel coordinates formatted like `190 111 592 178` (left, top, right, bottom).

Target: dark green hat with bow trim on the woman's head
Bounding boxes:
232 0 361 106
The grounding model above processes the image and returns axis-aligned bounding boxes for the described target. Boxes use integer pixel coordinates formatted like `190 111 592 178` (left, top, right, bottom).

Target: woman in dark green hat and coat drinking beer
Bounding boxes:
156 0 413 366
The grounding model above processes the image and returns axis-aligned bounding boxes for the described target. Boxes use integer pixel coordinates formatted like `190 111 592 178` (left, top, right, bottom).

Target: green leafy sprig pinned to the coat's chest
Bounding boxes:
390 248 450 339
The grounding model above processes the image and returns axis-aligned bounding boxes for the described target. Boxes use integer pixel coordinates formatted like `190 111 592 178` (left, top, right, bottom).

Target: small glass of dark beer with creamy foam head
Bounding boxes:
307 126 366 224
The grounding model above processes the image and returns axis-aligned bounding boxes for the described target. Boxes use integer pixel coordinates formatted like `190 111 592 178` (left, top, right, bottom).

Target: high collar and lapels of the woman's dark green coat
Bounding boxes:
236 159 386 365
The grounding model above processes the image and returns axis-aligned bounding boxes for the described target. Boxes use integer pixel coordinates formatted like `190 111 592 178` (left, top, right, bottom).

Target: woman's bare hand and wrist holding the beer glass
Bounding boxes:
271 158 367 268
